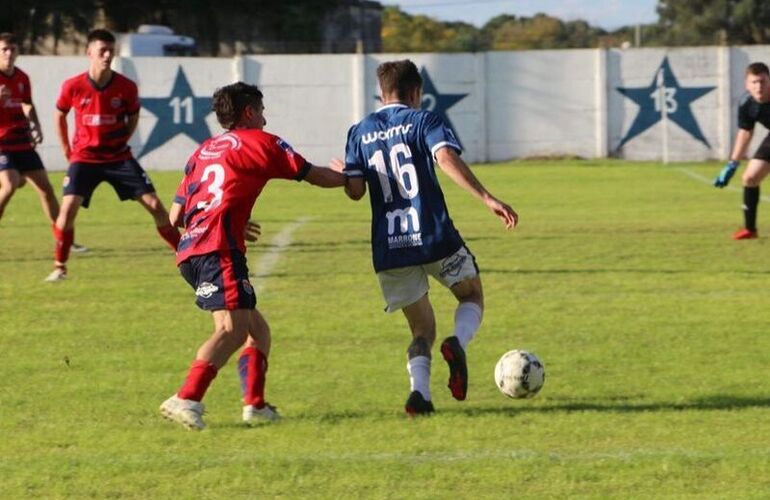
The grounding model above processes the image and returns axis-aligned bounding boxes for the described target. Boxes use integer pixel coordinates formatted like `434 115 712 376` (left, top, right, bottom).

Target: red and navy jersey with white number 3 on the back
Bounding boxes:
174 129 311 264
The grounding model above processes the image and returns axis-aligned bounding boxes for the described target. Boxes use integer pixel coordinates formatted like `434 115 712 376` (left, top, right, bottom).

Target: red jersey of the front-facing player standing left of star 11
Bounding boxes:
56 71 141 163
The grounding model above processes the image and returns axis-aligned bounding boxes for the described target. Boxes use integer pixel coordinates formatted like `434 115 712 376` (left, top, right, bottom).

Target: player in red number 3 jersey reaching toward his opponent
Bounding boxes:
160 82 345 430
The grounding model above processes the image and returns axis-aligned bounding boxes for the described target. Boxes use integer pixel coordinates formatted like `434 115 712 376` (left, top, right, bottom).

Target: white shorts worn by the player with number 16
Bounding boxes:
377 246 479 312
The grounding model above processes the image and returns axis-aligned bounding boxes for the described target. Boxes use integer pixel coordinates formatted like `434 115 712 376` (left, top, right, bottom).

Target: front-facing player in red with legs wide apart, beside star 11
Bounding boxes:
46 29 179 281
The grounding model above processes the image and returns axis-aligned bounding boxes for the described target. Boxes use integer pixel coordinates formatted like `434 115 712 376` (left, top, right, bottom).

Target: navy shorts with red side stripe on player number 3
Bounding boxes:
179 250 257 311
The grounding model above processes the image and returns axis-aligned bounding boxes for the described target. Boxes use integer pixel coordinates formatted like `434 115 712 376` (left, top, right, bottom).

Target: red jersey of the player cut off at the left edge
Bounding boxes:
0 68 34 152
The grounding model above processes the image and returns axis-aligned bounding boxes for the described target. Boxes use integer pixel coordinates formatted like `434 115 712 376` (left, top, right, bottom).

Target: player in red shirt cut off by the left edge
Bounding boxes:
0 33 85 251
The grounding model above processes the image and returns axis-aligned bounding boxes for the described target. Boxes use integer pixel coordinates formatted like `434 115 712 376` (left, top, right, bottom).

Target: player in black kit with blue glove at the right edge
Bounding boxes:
714 62 770 240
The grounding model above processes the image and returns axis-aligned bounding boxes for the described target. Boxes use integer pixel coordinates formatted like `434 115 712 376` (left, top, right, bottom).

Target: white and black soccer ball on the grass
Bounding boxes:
495 350 545 399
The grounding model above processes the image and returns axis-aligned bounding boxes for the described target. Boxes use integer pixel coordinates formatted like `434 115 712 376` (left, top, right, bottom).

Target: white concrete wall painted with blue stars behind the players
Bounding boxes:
18 46 770 170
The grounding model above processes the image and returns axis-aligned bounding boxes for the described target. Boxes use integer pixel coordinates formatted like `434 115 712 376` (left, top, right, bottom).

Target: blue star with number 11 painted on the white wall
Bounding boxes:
139 66 211 158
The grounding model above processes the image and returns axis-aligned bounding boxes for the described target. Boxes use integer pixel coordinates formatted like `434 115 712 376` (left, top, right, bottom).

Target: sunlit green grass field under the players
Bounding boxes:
0 161 770 498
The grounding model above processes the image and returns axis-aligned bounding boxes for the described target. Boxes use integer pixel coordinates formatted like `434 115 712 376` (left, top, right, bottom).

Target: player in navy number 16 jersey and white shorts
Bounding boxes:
335 60 518 416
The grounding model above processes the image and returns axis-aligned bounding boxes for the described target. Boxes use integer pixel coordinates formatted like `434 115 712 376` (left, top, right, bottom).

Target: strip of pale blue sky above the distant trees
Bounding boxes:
380 0 658 30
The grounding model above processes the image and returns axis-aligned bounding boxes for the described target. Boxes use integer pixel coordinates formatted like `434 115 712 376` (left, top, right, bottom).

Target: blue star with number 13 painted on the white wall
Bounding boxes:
616 57 716 149
